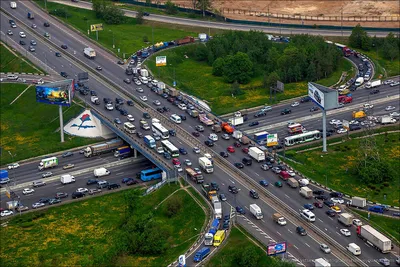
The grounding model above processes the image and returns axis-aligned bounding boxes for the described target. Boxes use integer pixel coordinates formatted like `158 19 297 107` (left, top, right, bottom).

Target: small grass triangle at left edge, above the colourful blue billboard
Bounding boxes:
0 42 44 73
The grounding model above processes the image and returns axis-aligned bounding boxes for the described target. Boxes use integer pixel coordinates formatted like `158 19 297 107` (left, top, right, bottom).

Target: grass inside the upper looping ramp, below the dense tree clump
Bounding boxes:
145 46 351 115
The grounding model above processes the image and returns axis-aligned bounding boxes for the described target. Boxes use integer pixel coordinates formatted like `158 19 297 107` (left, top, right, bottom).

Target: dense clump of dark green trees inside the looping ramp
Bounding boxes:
193 31 342 84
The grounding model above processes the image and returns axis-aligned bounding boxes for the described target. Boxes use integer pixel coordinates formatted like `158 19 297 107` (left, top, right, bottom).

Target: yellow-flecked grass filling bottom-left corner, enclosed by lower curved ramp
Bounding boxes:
0 185 205 266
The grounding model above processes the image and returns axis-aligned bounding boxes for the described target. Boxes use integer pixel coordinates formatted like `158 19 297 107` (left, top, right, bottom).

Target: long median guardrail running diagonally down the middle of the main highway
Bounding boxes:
0 8 368 266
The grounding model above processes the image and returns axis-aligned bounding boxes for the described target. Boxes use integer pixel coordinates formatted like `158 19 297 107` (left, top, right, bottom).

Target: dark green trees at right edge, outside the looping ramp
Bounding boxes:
349 24 400 61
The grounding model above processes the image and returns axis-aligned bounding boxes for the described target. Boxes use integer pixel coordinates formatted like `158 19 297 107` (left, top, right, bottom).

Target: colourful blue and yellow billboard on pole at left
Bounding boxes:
36 80 75 107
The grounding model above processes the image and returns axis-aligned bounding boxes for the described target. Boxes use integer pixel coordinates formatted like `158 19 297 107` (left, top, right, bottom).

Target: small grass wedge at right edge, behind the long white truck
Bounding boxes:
353 209 400 244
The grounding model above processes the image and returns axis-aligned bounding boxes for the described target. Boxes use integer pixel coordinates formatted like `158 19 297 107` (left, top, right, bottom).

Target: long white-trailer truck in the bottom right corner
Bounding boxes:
357 225 392 253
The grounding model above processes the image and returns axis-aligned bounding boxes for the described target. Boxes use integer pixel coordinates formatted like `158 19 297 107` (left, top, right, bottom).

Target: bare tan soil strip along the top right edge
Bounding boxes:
173 0 400 27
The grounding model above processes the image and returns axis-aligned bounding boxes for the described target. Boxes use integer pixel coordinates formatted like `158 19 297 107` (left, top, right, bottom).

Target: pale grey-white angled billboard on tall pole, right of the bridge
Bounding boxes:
308 82 339 110
